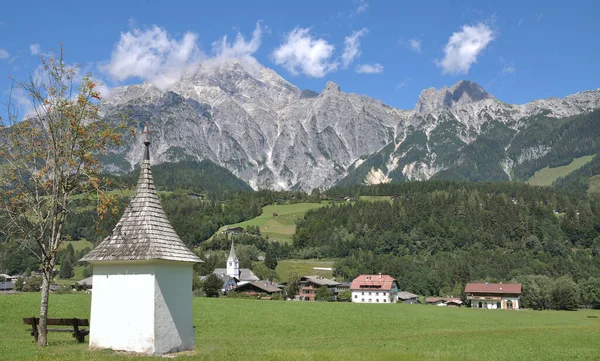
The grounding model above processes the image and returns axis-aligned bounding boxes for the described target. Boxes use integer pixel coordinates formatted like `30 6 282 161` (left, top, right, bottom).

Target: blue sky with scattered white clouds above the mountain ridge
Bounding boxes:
0 0 600 115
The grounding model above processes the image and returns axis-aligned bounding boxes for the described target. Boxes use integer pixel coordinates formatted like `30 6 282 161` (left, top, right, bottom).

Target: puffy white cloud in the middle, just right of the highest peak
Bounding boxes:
271 28 339 78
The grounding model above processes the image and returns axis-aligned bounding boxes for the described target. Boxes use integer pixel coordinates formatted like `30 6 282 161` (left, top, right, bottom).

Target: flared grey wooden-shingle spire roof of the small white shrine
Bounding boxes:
81 126 202 263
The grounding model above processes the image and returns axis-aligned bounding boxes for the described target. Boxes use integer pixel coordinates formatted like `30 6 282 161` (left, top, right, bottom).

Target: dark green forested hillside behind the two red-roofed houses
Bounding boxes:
314 181 600 294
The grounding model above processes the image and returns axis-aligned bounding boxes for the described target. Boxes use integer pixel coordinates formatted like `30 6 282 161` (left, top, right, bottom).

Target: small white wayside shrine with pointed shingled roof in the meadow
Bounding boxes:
81 129 202 355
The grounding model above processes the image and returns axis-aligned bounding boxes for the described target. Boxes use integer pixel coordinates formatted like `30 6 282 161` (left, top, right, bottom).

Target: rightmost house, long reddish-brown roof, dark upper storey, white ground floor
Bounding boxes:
465 282 521 310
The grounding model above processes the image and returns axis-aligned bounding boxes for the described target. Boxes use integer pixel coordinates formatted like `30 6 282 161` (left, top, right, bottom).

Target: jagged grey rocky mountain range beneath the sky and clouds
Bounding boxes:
103 59 600 191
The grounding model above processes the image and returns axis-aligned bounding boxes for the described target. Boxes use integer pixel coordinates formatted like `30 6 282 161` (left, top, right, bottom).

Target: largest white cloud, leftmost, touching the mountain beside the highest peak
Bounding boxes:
101 25 203 88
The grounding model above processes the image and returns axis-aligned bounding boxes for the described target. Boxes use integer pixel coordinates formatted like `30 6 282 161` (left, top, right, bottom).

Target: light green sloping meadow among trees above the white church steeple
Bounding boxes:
217 202 328 243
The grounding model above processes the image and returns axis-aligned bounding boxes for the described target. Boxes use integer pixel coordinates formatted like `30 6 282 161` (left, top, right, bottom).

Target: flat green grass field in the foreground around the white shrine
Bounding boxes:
0 293 600 361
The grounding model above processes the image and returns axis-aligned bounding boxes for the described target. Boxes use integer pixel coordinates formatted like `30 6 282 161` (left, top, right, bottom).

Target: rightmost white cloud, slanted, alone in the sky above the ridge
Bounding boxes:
436 23 494 74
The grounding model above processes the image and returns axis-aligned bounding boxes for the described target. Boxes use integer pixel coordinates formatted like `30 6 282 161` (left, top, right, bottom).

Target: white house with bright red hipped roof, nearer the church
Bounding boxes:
350 273 398 303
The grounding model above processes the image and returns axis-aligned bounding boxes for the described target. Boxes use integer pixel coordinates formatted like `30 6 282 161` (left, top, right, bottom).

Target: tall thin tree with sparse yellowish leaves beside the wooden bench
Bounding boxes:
0 45 120 346
